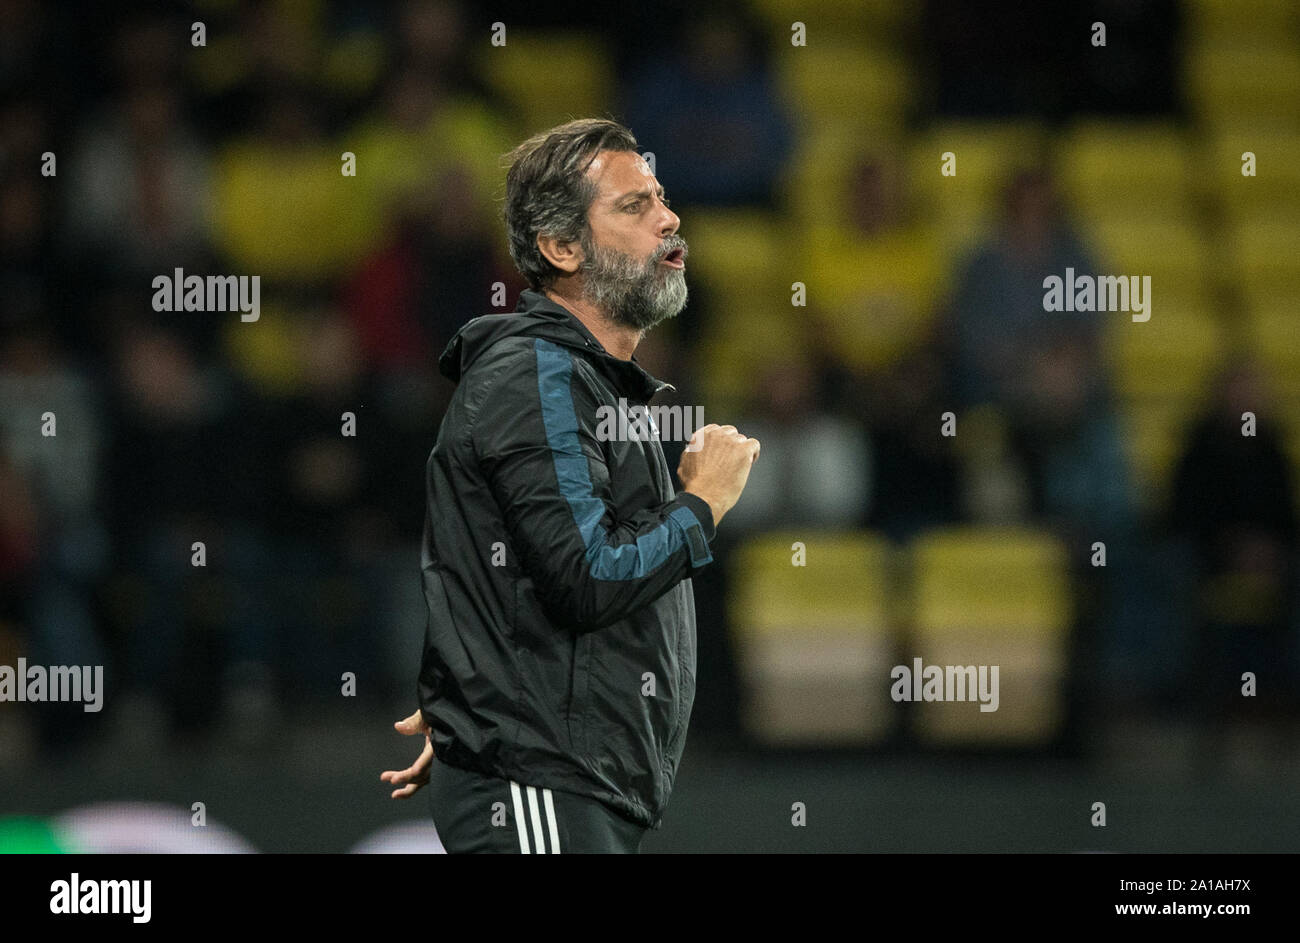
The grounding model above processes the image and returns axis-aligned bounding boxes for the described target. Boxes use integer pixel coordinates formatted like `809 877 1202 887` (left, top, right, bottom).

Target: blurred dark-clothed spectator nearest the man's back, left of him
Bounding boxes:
254 304 400 705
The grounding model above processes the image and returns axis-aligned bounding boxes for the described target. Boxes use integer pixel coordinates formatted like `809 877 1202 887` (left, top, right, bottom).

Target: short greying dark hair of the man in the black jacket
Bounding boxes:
504 118 637 290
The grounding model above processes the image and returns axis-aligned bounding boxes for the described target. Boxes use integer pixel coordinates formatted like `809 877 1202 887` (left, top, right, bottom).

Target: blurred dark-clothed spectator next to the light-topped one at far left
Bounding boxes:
104 320 272 750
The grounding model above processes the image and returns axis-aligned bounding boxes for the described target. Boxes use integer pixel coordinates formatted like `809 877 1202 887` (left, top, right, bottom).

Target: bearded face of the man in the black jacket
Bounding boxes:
579 151 686 332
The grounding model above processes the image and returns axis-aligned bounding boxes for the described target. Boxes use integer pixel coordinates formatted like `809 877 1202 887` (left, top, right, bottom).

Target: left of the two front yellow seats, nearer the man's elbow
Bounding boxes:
729 532 897 745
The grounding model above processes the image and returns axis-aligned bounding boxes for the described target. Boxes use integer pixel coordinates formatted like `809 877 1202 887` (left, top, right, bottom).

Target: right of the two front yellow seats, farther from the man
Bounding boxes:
902 528 1073 747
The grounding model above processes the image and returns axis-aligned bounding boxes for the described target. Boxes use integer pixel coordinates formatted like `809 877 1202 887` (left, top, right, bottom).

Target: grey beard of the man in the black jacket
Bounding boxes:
579 237 686 332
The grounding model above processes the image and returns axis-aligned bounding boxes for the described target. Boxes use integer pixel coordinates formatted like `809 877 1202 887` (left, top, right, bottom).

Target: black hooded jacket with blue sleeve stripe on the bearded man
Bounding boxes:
419 284 714 827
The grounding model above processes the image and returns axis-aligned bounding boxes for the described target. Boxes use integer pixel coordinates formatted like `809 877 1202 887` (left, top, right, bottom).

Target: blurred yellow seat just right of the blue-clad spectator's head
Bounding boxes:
1056 121 1195 216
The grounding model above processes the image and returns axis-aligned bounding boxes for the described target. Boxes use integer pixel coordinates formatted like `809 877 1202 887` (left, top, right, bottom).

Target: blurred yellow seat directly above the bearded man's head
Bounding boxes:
475 29 614 134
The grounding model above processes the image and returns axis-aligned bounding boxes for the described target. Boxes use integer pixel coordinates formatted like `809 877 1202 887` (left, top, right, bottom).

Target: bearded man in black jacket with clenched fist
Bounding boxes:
381 120 759 853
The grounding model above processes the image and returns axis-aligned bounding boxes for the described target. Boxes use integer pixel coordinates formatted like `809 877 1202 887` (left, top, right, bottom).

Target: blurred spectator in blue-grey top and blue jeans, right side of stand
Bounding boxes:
945 170 1136 544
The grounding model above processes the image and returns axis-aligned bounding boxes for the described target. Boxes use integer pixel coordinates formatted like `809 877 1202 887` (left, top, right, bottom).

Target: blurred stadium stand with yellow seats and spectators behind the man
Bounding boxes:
0 0 1300 851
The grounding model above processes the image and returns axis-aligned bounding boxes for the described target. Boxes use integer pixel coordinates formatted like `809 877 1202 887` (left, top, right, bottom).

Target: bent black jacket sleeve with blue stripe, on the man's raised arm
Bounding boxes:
471 339 715 628
